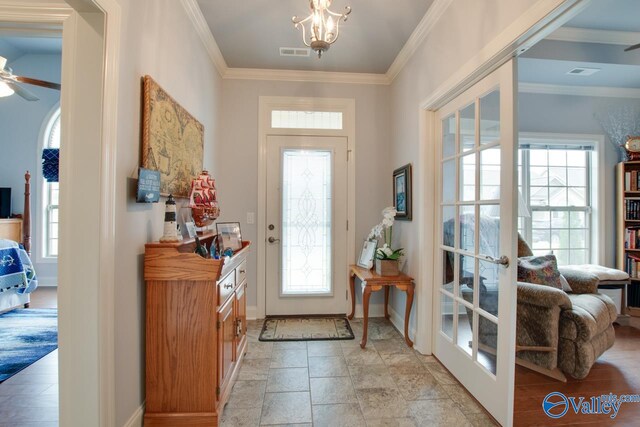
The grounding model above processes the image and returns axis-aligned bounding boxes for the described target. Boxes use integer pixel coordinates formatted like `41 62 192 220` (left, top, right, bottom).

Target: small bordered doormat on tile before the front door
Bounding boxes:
259 316 354 341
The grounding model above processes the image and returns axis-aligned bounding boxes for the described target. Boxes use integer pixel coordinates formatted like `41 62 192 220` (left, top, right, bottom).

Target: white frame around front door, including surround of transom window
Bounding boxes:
256 96 356 319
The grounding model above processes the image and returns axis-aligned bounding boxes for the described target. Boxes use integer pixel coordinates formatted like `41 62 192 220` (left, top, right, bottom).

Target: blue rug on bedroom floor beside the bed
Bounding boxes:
0 308 58 383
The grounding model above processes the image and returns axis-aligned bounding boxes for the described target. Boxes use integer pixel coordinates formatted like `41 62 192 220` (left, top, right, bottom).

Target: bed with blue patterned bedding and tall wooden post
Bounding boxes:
0 172 38 313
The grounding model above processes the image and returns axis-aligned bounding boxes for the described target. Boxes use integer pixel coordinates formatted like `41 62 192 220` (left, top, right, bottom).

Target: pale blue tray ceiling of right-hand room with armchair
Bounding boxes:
518 0 640 89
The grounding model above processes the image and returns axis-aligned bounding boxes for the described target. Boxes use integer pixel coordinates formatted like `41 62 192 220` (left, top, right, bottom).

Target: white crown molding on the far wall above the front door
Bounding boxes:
228 68 390 85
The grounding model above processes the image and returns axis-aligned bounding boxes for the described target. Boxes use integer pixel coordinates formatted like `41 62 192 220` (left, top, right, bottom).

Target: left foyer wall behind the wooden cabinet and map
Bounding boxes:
115 0 221 426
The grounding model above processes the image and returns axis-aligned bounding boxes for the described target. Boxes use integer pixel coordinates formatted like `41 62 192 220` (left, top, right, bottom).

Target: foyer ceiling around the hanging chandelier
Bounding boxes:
198 0 433 74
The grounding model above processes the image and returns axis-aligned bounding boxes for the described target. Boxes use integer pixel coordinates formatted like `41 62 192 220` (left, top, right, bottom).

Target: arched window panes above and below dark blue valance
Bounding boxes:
42 109 60 258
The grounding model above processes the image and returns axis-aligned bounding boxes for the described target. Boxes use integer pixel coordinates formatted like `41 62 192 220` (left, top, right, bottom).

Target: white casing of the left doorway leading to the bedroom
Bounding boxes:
0 0 120 426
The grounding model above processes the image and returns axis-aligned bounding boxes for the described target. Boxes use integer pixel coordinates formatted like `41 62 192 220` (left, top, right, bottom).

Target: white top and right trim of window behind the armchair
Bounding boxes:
519 132 609 265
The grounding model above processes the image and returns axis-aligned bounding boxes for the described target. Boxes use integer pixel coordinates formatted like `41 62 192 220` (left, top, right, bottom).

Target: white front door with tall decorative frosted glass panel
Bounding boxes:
266 135 348 316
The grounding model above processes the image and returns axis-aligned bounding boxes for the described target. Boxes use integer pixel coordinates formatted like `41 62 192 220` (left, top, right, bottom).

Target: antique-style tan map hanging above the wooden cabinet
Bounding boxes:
142 76 204 197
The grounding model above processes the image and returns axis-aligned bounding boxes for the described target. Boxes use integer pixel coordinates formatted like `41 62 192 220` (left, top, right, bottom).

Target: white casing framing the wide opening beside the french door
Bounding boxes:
416 0 593 354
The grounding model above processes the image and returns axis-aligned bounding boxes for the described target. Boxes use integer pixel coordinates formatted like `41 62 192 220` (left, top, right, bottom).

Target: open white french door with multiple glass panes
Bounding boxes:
434 60 518 425
